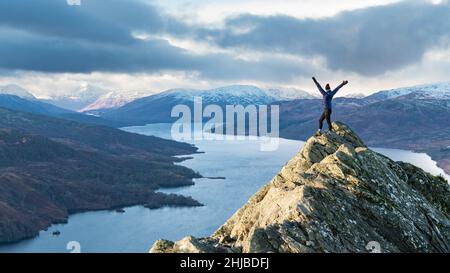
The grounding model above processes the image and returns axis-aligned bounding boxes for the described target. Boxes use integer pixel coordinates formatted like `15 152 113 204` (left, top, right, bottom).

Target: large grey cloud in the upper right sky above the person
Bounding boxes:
197 1 450 76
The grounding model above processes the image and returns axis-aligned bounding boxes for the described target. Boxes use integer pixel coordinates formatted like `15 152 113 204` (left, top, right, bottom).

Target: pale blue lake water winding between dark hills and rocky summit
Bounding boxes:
0 124 442 252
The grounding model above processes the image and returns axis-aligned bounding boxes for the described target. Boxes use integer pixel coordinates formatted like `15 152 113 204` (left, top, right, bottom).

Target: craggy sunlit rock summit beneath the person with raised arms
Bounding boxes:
150 122 450 253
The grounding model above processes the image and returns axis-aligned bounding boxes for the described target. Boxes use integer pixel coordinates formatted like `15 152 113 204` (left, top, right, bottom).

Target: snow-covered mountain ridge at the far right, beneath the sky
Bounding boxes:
366 83 450 100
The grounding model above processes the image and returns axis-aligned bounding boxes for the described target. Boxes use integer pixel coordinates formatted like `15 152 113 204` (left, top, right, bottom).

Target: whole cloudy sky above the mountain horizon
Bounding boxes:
0 0 450 96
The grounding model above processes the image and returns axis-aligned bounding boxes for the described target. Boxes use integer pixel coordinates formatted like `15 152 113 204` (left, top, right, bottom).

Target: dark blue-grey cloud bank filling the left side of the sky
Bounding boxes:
0 0 303 80
